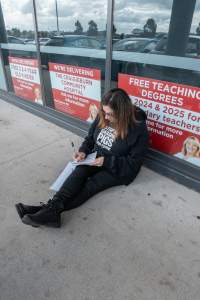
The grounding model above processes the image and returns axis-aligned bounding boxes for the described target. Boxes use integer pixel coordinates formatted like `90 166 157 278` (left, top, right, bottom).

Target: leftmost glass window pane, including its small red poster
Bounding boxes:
0 0 43 105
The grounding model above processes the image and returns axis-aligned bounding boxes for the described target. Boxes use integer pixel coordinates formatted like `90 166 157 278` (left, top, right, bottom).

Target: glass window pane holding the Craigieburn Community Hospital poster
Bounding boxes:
36 0 107 122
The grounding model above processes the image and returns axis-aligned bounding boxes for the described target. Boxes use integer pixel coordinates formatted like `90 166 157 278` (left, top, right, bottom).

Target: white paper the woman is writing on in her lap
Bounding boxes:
50 152 97 192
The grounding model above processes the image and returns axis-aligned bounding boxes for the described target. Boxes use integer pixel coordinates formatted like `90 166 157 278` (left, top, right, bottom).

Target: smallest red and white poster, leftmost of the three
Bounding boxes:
8 56 43 105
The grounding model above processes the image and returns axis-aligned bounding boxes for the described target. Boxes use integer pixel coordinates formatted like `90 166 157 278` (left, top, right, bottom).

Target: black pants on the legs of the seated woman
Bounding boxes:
54 166 123 210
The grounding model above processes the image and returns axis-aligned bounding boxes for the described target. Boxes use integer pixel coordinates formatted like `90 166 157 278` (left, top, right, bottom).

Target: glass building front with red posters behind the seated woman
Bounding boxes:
0 0 200 190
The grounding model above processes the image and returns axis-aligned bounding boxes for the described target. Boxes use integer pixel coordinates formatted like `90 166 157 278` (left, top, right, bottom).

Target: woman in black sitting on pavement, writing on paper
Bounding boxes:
16 88 148 227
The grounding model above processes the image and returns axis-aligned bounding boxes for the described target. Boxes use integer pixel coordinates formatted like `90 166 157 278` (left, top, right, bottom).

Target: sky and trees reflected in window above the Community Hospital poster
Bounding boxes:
36 0 107 48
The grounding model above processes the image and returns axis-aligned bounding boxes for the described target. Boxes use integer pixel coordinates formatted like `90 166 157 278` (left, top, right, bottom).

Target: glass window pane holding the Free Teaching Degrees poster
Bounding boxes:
111 0 200 167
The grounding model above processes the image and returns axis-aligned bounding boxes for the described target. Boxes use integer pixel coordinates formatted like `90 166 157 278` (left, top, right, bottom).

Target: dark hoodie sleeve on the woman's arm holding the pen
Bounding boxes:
79 117 99 155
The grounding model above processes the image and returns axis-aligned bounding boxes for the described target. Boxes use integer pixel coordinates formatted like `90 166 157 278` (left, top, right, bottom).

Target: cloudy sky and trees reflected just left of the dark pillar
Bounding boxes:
114 0 173 39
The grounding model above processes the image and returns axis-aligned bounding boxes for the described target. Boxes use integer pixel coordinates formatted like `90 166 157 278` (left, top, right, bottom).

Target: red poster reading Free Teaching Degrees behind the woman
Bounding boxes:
118 74 200 166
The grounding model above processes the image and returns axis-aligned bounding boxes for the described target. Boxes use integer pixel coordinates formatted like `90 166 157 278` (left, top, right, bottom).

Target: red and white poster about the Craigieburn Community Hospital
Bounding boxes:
49 63 101 122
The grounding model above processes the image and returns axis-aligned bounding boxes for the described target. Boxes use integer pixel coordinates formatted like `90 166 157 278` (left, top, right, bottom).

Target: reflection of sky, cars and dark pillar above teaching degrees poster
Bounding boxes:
113 0 200 58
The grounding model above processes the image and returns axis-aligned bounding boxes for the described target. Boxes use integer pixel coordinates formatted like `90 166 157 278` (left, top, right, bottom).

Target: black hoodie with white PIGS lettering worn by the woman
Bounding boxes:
79 108 148 184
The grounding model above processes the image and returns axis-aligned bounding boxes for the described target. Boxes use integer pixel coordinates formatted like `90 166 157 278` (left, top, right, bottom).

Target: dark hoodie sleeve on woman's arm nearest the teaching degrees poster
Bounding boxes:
103 109 148 178
